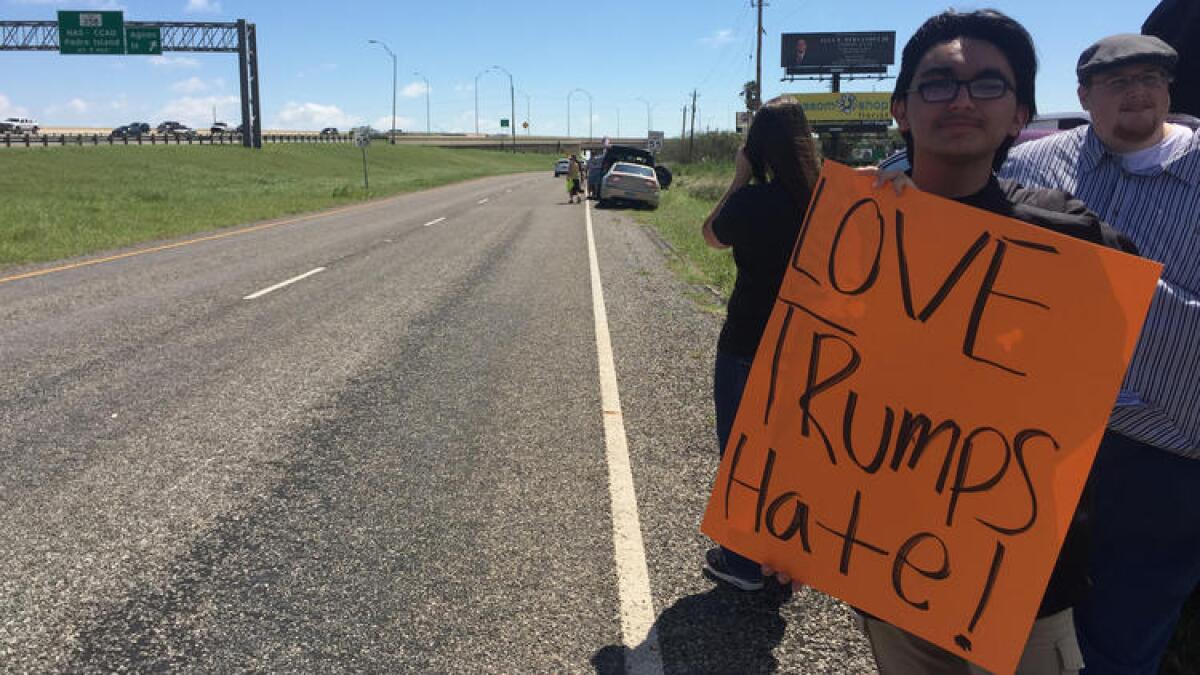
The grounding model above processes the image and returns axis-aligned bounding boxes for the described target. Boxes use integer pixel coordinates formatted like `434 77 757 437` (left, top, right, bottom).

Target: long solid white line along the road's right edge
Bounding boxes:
583 196 662 675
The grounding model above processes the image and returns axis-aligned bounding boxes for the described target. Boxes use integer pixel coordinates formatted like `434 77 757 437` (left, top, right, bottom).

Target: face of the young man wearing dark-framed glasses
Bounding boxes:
892 37 1030 163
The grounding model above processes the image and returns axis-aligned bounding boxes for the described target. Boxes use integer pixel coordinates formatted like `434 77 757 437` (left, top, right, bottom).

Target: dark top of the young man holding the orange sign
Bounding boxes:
955 177 1138 617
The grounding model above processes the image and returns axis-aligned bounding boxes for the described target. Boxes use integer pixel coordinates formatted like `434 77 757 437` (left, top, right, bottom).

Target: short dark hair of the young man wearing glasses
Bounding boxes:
892 10 1038 169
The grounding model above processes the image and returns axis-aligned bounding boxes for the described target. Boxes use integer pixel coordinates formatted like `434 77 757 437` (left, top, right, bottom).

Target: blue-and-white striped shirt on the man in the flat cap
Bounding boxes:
1001 126 1200 459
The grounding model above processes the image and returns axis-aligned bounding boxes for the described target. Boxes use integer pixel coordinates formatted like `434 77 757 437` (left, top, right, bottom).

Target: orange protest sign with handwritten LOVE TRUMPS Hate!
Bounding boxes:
702 162 1160 673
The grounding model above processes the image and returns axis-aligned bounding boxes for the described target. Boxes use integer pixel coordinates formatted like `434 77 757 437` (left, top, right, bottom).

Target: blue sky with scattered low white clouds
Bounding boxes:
0 0 1158 137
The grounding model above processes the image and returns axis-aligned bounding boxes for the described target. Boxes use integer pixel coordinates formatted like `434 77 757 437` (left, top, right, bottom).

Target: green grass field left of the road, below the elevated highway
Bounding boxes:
0 143 554 267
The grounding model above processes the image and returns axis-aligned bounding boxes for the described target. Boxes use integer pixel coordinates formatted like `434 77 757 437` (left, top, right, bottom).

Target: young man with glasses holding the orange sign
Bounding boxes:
844 10 1135 675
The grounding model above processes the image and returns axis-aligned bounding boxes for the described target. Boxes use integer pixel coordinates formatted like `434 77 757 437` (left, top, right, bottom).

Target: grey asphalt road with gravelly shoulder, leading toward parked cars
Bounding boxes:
0 172 874 674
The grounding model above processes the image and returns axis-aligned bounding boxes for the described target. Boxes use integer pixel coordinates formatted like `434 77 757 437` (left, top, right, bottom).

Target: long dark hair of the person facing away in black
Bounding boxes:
744 97 821 213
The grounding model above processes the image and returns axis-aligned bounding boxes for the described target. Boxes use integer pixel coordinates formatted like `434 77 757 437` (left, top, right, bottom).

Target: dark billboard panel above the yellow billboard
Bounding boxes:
780 30 896 74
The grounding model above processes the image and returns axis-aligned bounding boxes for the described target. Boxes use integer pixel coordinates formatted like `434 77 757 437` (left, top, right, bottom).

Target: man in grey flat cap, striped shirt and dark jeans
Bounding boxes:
1001 35 1200 675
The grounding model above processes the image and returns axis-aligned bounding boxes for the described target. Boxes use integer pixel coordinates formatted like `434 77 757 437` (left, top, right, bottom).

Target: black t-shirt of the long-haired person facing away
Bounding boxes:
713 183 809 358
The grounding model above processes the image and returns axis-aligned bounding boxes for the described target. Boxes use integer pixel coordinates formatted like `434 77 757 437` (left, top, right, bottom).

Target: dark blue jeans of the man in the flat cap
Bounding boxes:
1075 431 1200 675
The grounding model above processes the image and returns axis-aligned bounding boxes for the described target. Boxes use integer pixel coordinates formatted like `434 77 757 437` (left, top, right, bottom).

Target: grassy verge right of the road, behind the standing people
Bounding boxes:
637 162 1200 675
